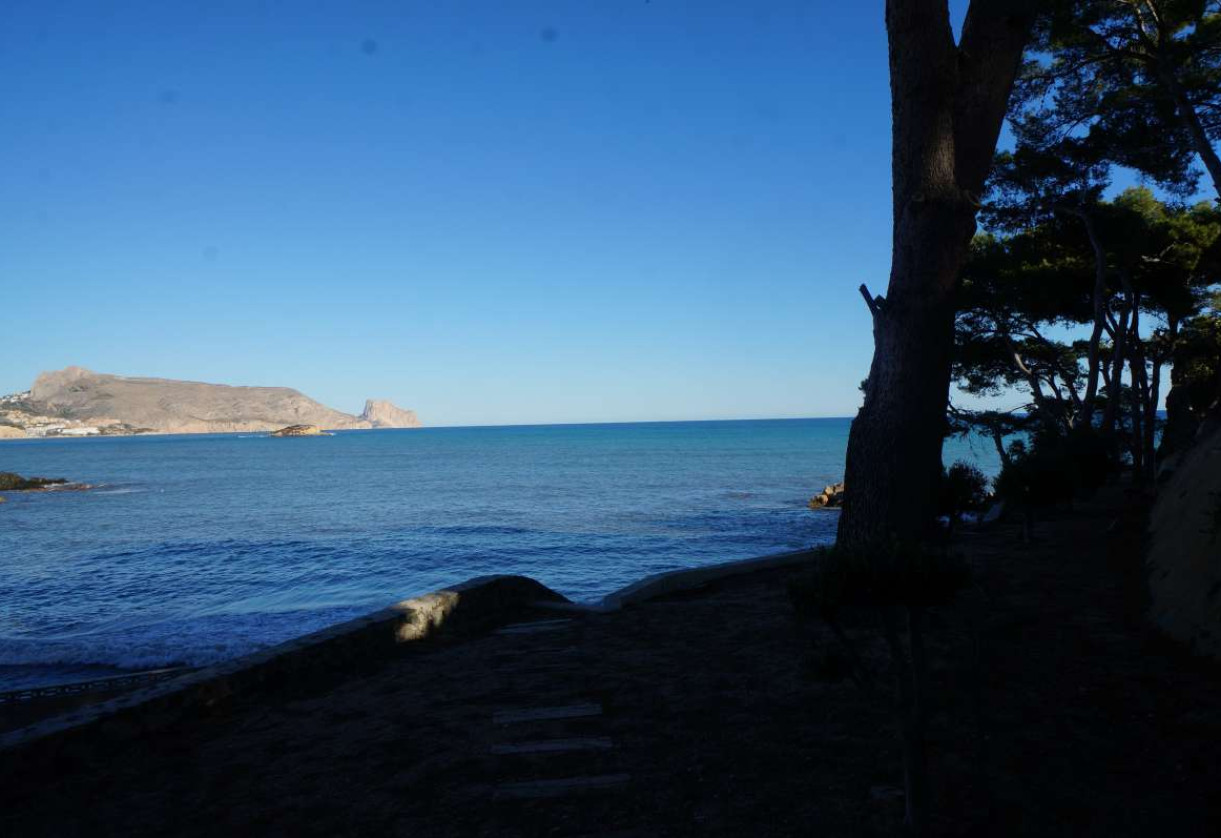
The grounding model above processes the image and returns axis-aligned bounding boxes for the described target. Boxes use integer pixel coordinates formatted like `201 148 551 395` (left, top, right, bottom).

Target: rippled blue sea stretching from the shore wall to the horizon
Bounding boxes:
0 419 996 691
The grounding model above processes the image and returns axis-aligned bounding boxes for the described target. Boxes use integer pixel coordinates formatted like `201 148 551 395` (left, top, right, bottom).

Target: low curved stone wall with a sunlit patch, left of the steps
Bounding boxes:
0 577 567 767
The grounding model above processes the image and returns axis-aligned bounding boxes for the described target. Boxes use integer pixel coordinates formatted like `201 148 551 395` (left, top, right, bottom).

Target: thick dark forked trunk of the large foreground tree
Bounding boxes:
839 0 1037 546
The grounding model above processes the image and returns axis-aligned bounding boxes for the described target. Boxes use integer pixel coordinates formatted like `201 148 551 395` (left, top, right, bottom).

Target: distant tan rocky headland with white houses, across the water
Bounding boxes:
0 366 420 440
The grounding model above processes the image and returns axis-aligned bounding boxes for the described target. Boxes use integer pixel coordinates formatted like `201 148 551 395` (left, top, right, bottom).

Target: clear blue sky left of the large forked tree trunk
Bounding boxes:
0 0 965 425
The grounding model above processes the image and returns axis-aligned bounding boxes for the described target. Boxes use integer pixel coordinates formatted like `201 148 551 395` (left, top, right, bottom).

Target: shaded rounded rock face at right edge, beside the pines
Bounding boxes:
1147 428 1221 660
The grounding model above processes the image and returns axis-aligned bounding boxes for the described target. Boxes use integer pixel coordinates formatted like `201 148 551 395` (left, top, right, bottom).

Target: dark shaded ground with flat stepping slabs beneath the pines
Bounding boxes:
0 488 1221 836
